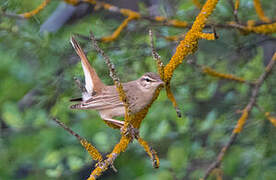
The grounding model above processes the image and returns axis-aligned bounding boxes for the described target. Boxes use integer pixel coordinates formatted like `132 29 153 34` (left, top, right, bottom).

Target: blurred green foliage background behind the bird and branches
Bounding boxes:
0 0 276 180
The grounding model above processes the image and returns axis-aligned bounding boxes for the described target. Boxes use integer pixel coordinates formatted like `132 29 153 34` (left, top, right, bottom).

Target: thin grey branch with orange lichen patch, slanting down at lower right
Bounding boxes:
202 52 276 180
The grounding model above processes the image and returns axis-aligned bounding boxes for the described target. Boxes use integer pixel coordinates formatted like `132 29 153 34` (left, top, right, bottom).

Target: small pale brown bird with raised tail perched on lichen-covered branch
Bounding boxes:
70 37 165 128
